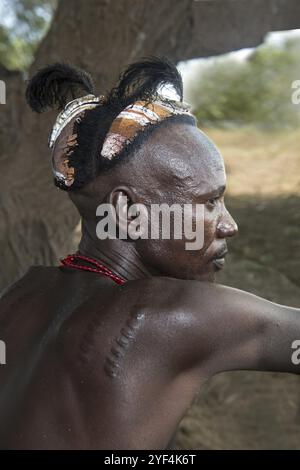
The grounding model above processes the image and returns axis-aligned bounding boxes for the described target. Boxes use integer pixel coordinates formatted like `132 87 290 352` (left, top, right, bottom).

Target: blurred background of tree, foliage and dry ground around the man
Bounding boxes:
0 0 300 449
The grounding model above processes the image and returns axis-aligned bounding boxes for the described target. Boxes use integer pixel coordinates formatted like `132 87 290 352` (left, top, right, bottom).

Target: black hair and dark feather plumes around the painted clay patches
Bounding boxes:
26 56 196 190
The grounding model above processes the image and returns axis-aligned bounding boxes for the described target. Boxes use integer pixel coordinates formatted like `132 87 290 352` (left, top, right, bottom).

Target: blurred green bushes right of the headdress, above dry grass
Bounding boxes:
190 40 300 127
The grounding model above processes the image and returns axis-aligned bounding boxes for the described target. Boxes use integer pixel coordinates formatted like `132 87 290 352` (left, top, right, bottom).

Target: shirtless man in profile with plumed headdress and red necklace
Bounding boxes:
0 58 300 449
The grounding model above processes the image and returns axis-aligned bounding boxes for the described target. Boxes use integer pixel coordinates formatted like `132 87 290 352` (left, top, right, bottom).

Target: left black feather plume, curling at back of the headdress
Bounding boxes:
26 63 94 113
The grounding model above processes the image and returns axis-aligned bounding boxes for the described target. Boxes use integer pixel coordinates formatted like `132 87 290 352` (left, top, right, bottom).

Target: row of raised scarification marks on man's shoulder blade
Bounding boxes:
104 312 145 378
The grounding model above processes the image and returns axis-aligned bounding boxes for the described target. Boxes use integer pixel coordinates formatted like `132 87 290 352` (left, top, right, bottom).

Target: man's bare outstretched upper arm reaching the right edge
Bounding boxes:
166 281 300 375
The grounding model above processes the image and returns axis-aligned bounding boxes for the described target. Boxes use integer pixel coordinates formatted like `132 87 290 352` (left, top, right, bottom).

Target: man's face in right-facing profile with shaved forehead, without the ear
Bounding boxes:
134 124 237 281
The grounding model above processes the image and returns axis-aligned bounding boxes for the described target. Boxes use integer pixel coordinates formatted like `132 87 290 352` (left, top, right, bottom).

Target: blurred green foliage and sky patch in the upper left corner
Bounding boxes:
0 0 57 70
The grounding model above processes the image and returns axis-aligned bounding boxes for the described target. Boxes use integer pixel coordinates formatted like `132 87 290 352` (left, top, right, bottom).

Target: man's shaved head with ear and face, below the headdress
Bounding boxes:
82 122 237 280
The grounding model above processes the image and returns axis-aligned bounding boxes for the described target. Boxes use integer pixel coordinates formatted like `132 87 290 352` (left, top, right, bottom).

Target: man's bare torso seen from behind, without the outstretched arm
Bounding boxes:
0 267 201 449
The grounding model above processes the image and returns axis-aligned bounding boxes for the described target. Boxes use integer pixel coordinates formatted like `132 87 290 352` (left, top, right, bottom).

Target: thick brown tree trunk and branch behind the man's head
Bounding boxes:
0 0 300 289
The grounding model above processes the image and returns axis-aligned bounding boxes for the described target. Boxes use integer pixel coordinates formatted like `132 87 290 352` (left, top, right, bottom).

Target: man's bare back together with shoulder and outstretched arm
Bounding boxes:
0 267 300 449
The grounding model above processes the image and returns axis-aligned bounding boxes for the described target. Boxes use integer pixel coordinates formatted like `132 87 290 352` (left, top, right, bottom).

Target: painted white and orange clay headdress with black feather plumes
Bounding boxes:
26 57 195 190
